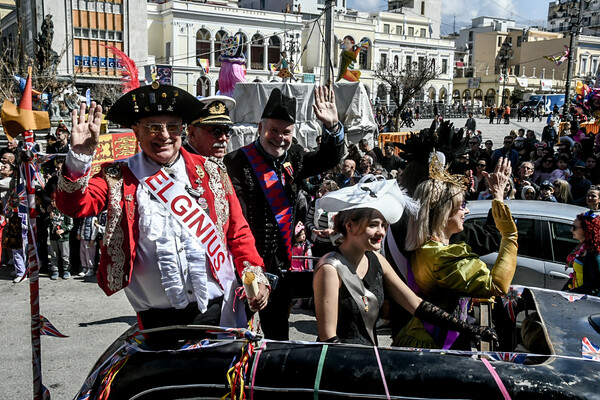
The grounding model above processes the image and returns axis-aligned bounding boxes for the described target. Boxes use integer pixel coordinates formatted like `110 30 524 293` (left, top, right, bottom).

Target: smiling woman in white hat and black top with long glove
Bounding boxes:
313 175 495 345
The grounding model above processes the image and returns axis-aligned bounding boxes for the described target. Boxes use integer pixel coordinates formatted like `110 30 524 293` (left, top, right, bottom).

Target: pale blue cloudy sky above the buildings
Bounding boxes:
347 0 550 34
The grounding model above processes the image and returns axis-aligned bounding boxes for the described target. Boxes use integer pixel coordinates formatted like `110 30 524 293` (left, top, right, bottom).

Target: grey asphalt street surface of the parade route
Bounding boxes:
0 114 544 400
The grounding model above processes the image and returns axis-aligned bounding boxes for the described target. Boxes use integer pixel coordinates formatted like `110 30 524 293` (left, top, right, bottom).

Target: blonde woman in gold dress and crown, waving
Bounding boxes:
393 158 517 349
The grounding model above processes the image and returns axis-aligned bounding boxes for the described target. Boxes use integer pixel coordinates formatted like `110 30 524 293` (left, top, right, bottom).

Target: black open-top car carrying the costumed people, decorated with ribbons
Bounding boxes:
75 287 600 400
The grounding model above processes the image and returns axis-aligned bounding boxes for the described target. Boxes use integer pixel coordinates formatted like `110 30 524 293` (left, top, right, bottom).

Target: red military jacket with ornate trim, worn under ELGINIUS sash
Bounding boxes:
56 149 264 295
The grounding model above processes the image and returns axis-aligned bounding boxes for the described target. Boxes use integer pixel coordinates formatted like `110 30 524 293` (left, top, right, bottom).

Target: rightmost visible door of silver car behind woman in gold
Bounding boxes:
543 219 578 290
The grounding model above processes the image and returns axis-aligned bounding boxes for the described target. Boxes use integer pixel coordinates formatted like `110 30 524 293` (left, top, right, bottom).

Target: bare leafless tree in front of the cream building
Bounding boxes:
374 59 440 131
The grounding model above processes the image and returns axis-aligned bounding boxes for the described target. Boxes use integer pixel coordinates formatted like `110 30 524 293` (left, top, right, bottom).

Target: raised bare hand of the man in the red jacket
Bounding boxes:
71 101 102 156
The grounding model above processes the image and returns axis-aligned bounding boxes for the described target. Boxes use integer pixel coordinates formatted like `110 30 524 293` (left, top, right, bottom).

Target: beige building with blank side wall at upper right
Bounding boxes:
452 25 600 106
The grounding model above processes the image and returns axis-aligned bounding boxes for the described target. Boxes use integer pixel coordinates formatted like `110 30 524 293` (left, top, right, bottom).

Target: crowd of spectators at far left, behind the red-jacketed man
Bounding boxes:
0 125 105 283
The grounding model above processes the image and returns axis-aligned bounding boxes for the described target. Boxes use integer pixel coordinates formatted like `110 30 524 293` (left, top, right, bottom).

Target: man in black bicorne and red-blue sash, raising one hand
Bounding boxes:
225 87 344 340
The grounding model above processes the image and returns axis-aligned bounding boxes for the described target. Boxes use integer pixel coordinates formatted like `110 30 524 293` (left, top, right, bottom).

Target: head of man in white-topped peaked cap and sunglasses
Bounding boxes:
183 96 235 159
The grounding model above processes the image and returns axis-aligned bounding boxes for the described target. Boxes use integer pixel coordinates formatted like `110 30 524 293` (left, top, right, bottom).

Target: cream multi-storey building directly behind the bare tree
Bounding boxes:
303 12 454 106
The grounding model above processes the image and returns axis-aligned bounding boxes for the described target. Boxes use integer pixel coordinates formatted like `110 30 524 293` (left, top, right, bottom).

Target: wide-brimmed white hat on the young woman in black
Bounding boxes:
319 175 419 224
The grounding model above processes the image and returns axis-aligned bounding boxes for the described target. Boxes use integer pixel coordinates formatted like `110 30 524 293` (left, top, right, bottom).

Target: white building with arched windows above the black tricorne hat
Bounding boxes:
147 0 303 96
